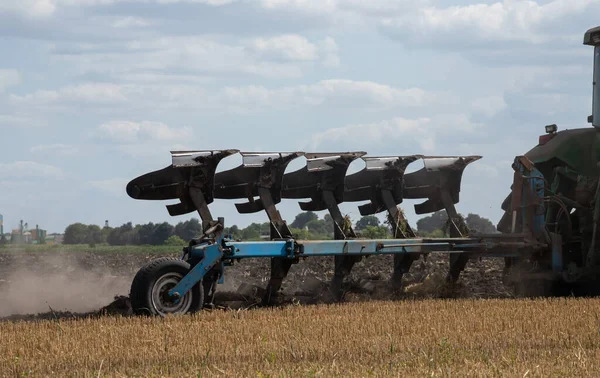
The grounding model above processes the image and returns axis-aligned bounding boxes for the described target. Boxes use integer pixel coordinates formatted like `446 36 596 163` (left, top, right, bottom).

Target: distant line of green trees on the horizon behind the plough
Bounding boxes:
63 211 496 245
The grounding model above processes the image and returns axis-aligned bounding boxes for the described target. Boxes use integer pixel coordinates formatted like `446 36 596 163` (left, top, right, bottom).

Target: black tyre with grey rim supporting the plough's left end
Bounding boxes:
129 257 204 316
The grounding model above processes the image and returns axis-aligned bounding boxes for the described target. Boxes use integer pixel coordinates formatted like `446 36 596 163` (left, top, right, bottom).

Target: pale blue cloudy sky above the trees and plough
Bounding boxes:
0 0 600 232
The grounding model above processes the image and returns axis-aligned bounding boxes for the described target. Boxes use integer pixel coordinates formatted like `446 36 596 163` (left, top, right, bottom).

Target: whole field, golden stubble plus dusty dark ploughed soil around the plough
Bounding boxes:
0 247 600 377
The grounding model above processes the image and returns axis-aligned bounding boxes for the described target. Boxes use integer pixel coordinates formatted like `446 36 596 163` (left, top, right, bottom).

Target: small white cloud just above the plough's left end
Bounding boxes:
98 121 193 143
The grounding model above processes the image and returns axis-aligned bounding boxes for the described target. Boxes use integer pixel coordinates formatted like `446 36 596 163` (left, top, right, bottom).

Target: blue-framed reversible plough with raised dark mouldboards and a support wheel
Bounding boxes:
127 150 542 315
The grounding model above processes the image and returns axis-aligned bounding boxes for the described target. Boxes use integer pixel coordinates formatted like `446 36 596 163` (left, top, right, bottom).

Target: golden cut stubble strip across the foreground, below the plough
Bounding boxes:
0 299 600 377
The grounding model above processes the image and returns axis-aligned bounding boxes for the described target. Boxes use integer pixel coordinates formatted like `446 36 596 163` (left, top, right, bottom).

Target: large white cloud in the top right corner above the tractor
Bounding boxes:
381 0 600 49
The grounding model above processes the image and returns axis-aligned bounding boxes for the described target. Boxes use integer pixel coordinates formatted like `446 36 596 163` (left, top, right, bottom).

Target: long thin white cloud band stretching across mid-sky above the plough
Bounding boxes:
11 79 440 113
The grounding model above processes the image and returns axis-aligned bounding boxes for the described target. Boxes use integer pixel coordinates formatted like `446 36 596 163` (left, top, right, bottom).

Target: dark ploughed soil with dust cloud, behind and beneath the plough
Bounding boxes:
0 249 513 320
